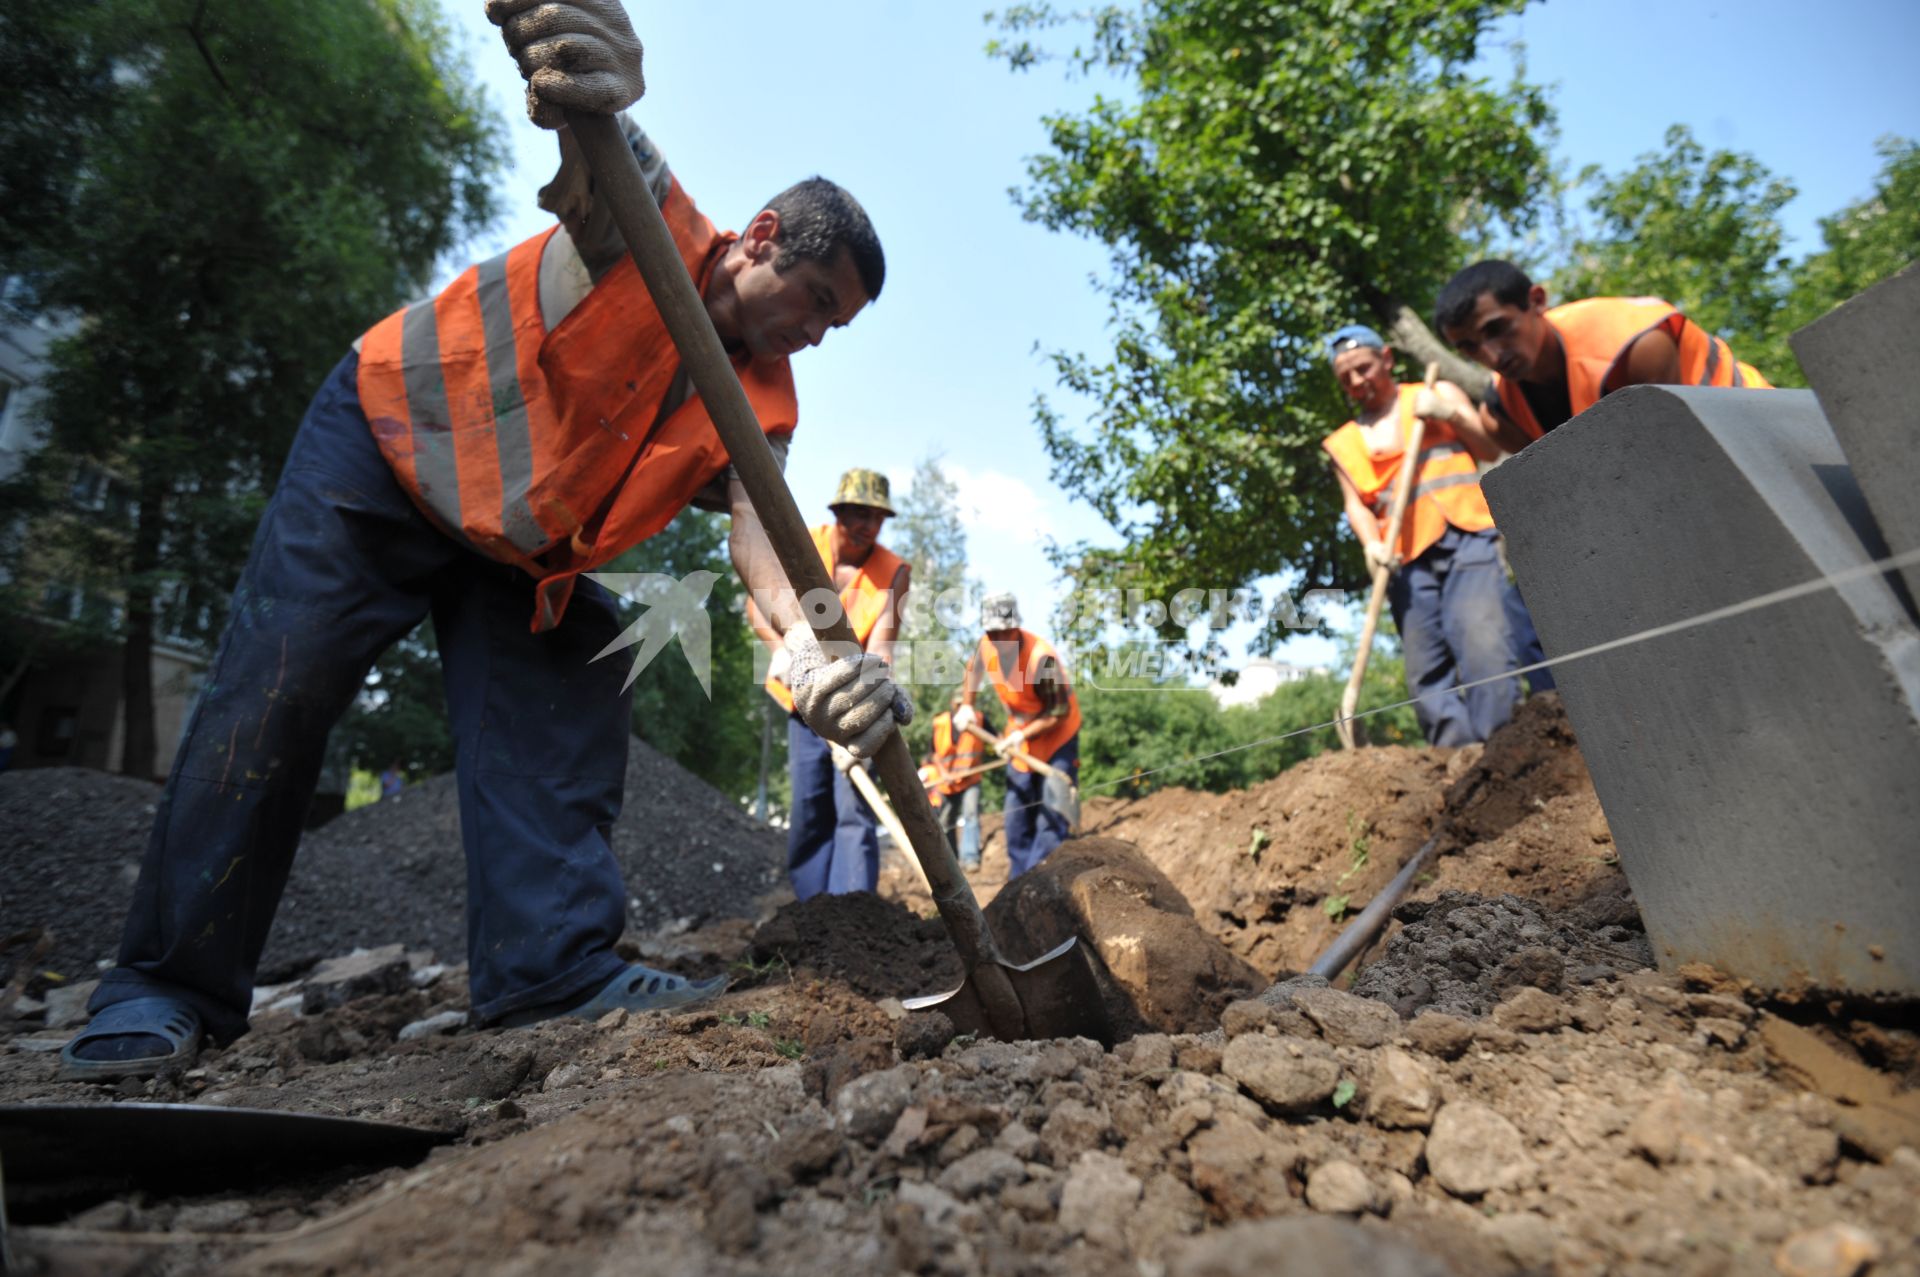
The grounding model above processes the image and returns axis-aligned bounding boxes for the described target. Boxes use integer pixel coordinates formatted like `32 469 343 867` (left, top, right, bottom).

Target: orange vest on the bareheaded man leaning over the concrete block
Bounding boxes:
1494 298 1772 440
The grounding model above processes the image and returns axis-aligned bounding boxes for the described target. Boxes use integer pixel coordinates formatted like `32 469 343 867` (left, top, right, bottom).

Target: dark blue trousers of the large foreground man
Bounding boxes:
90 355 630 1041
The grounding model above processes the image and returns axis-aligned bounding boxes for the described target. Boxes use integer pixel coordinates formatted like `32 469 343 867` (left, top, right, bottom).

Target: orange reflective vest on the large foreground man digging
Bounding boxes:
359 181 799 632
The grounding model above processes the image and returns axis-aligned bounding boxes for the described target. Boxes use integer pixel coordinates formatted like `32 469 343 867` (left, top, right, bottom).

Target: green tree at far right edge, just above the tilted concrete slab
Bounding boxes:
1763 136 1920 336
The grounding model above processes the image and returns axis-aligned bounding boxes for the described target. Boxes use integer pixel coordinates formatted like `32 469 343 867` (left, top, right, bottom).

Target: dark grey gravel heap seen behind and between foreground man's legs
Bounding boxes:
0 739 785 983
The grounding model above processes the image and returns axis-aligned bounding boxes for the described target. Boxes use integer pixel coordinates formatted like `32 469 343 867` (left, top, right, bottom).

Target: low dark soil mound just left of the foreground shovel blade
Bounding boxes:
751 891 960 999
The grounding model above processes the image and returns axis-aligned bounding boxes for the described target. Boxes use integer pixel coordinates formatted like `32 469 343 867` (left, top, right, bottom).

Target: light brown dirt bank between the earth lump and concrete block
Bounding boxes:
1085 695 1624 979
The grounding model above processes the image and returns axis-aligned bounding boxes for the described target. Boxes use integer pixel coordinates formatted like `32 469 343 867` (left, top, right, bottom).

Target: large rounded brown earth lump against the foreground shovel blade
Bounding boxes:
987 837 1265 1037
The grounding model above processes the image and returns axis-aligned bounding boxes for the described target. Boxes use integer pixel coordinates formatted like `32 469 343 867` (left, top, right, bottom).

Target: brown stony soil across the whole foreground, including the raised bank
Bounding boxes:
0 701 1920 1277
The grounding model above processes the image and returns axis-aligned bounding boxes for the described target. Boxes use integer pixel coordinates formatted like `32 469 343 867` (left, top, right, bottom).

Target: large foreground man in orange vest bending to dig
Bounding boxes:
61 0 912 1079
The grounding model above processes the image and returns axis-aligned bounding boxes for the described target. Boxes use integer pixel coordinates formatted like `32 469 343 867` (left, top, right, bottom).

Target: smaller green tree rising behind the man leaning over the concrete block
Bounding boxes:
1555 125 1805 386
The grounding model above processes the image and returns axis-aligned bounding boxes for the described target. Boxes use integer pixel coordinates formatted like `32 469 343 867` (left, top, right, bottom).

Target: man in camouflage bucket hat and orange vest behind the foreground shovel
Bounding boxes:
747 470 912 901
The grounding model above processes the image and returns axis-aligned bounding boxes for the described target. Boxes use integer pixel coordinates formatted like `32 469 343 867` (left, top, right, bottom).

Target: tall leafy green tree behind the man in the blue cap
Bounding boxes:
989 0 1551 638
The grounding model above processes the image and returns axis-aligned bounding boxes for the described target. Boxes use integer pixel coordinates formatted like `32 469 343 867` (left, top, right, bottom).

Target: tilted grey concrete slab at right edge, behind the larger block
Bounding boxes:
1793 265 1920 603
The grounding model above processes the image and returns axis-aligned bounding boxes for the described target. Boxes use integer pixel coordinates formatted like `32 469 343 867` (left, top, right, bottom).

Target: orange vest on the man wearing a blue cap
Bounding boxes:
1321 384 1494 563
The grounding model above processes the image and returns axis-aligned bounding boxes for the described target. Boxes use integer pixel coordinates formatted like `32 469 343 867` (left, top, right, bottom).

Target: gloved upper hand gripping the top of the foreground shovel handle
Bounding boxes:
486 0 647 129
